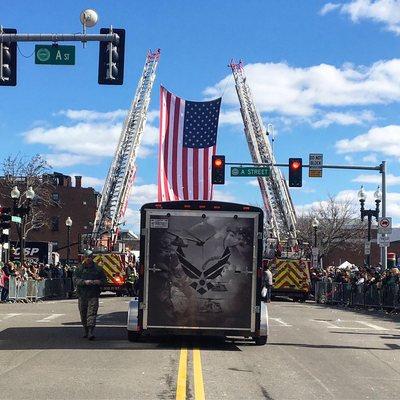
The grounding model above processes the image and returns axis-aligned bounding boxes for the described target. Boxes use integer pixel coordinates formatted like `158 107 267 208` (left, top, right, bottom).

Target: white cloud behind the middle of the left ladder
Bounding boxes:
23 110 158 167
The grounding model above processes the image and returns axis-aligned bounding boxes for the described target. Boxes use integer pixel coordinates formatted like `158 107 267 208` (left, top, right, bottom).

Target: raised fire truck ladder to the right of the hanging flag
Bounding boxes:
229 61 297 246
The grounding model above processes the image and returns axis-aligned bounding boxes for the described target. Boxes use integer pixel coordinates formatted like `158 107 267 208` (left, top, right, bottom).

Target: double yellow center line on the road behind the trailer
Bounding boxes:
176 348 205 400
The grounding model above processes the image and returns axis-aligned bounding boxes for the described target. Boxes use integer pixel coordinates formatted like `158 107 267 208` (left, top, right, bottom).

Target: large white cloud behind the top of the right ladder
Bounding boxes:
204 59 400 125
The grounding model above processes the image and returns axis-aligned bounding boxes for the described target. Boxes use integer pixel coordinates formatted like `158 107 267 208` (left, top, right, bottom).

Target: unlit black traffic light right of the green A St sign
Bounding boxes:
98 28 125 85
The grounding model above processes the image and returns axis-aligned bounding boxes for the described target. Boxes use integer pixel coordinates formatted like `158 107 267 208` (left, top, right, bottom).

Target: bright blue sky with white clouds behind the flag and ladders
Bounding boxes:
0 0 400 229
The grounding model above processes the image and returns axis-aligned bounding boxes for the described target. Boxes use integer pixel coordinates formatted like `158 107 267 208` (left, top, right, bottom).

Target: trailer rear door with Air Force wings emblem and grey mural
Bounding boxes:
142 209 260 334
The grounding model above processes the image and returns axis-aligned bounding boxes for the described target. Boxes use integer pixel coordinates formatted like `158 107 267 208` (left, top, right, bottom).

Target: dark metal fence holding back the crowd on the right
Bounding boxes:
315 282 400 311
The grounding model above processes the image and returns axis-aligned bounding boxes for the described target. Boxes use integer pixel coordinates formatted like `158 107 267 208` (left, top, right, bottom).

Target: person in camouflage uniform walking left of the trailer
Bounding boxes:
74 250 107 340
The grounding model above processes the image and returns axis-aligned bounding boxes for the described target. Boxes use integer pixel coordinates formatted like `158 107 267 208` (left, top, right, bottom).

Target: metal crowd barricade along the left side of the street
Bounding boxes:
4 276 72 302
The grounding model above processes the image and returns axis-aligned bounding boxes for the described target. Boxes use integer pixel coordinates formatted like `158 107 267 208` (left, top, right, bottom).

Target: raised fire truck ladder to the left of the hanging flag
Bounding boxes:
92 49 160 245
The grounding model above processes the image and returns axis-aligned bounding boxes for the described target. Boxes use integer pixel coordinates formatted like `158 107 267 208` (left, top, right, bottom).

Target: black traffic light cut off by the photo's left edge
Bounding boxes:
0 28 17 86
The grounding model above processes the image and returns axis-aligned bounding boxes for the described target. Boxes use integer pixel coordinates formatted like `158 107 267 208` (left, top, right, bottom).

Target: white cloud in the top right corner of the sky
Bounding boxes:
320 0 400 35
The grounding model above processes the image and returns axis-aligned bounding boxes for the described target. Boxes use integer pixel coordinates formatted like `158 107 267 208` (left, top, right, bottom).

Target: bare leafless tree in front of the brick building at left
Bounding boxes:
1 154 57 239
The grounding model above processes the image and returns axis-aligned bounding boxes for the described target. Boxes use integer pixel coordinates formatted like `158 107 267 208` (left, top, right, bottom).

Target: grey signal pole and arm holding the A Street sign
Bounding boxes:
225 161 387 269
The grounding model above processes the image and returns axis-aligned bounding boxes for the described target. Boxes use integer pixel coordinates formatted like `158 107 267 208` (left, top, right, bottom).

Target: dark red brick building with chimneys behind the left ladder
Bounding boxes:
0 172 99 260
